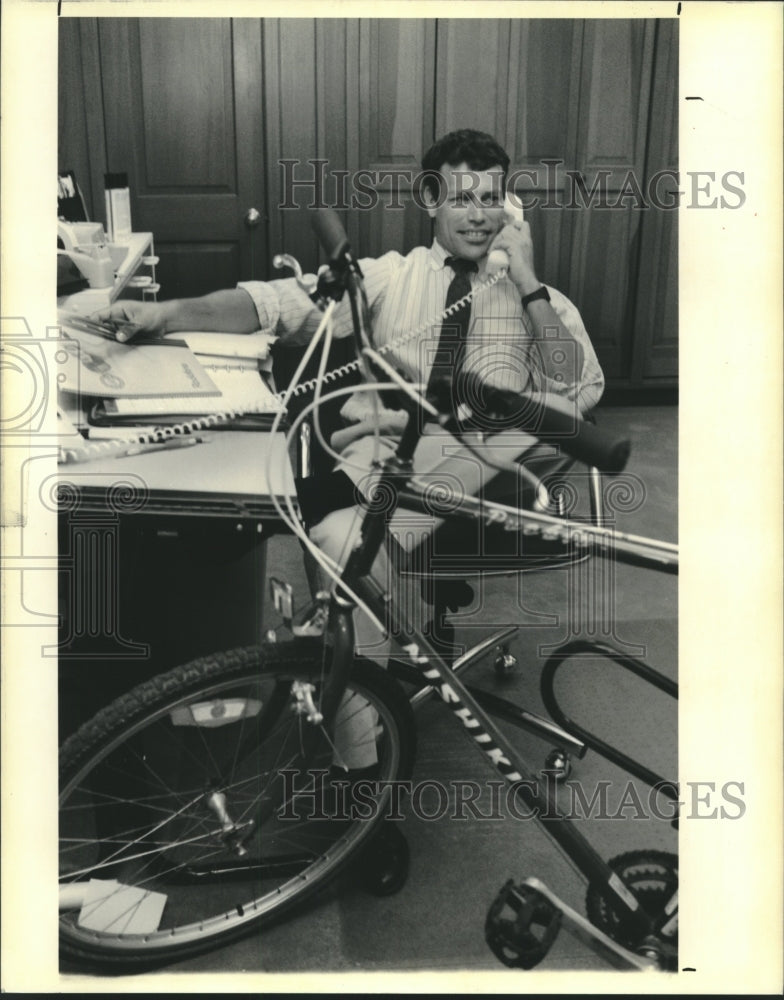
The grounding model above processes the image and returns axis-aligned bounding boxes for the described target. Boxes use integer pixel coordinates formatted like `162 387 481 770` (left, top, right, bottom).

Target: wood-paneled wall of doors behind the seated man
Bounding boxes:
59 18 678 385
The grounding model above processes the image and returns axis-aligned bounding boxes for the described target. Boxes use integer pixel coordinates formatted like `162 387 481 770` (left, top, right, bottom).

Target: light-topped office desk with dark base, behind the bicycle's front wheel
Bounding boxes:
58 430 295 731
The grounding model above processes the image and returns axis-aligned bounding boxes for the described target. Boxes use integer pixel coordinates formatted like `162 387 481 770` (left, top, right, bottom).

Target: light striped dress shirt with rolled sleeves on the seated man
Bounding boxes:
238 241 604 432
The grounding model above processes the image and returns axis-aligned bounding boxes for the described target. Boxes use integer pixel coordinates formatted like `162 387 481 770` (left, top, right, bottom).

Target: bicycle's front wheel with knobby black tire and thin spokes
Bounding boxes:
60 639 416 971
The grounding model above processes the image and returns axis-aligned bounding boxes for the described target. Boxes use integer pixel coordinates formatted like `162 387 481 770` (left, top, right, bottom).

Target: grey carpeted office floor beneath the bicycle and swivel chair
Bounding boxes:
59 406 677 974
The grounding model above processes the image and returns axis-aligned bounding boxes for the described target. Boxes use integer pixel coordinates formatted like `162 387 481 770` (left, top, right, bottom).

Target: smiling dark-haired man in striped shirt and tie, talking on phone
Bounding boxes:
100 129 604 655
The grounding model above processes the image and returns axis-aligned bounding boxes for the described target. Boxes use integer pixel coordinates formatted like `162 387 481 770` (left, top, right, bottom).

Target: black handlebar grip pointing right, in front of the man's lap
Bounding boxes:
428 375 631 474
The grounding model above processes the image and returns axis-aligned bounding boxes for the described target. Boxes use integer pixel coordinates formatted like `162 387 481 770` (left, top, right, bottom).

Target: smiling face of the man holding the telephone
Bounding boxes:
425 163 504 261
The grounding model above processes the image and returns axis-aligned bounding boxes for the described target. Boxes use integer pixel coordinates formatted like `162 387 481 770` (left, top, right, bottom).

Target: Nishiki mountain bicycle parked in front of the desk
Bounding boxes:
60 212 677 970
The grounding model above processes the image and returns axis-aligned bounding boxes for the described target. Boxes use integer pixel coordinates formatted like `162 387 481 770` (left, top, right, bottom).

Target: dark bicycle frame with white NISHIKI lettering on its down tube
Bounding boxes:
286 221 677 968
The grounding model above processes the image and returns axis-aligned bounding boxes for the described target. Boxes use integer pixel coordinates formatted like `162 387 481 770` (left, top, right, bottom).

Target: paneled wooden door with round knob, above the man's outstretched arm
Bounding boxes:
63 18 268 298
